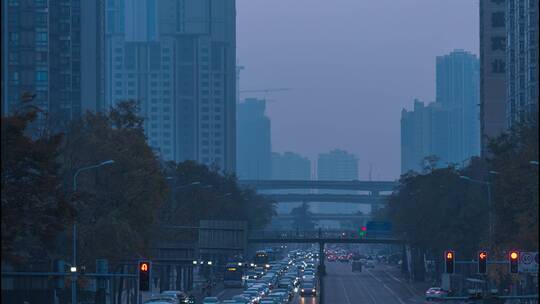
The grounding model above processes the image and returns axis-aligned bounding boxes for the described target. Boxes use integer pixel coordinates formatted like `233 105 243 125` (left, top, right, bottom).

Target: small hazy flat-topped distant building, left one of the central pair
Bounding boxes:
271 152 311 180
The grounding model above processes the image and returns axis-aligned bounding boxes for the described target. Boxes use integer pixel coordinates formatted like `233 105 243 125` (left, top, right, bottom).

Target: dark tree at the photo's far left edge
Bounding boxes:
1 108 73 263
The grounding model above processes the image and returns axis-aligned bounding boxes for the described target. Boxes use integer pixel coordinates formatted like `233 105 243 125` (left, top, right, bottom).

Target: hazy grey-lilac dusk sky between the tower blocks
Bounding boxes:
237 0 479 180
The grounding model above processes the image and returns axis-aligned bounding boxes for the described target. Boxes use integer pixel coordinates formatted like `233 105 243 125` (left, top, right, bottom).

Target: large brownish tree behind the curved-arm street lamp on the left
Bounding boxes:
61 101 168 265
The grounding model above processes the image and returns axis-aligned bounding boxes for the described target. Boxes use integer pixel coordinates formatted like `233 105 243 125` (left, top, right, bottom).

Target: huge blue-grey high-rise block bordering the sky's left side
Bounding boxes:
106 0 236 172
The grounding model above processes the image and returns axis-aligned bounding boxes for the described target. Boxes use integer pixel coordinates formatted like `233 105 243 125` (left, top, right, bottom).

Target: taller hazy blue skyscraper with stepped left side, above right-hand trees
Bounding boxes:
436 50 480 164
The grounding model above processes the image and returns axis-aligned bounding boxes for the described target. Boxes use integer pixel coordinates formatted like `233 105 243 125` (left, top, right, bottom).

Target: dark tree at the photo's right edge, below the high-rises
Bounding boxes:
488 116 539 254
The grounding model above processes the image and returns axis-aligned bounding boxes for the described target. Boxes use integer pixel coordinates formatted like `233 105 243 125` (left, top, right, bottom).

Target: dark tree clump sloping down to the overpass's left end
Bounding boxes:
162 161 276 239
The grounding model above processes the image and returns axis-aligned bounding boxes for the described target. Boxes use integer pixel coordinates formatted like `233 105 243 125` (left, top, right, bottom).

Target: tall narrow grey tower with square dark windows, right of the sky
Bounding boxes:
480 0 513 156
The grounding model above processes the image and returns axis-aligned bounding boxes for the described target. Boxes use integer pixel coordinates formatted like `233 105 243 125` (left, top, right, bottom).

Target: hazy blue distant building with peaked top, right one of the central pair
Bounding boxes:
317 149 358 181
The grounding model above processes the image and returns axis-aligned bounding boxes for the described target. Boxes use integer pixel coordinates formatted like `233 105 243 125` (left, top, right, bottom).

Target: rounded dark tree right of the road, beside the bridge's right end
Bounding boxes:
379 167 487 278
